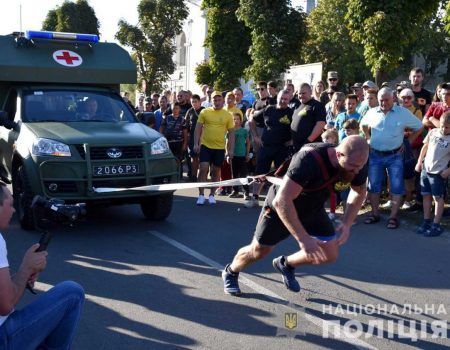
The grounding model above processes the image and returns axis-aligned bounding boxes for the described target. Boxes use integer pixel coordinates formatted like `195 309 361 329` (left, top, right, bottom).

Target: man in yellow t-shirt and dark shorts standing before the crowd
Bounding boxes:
194 91 234 205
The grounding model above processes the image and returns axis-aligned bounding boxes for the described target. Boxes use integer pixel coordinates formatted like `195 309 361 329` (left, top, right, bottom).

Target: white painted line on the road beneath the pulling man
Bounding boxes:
149 231 377 350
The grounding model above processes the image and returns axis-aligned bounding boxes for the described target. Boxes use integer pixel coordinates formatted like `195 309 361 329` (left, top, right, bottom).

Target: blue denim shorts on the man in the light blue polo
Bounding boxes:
368 150 405 195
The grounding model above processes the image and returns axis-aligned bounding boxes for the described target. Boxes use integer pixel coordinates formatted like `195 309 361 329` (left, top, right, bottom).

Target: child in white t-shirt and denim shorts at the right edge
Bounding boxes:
416 112 450 237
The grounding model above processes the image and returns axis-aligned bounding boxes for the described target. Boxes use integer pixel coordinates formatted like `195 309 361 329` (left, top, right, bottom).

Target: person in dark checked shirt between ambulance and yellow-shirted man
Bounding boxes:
159 102 189 163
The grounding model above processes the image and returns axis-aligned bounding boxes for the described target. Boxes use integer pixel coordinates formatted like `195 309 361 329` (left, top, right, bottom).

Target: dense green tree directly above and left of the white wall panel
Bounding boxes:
237 0 306 81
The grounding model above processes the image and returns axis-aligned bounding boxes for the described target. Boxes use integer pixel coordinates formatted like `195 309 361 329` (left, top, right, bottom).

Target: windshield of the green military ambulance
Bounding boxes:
22 89 138 123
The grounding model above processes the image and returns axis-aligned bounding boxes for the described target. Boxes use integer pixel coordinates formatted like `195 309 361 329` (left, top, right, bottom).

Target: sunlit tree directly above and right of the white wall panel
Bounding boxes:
300 0 370 83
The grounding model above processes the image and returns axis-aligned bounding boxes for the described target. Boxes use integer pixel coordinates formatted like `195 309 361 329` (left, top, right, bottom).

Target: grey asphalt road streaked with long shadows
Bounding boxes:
4 190 450 350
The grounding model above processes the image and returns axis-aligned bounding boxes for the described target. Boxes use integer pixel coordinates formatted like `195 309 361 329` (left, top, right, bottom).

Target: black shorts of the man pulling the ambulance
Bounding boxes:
254 205 336 246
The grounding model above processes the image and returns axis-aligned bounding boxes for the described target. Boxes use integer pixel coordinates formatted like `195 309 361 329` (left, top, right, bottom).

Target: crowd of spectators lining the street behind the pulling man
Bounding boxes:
124 68 450 236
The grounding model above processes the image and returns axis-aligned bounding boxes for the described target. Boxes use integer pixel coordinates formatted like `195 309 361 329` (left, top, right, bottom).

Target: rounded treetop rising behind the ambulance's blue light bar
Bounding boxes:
42 0 100 35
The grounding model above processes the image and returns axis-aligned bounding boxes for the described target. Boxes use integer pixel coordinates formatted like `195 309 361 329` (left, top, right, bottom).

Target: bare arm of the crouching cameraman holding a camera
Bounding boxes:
0 243 47 315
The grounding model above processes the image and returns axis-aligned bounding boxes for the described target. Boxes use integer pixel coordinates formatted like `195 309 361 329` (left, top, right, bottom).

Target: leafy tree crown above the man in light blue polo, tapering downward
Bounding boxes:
345 0 439 82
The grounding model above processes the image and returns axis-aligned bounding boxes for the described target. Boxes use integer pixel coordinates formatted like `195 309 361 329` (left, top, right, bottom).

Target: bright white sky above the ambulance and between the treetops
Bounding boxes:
0 0 305 42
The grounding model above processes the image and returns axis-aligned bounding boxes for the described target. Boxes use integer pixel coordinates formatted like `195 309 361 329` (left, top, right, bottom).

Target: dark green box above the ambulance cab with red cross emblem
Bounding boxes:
0 35 136 84
